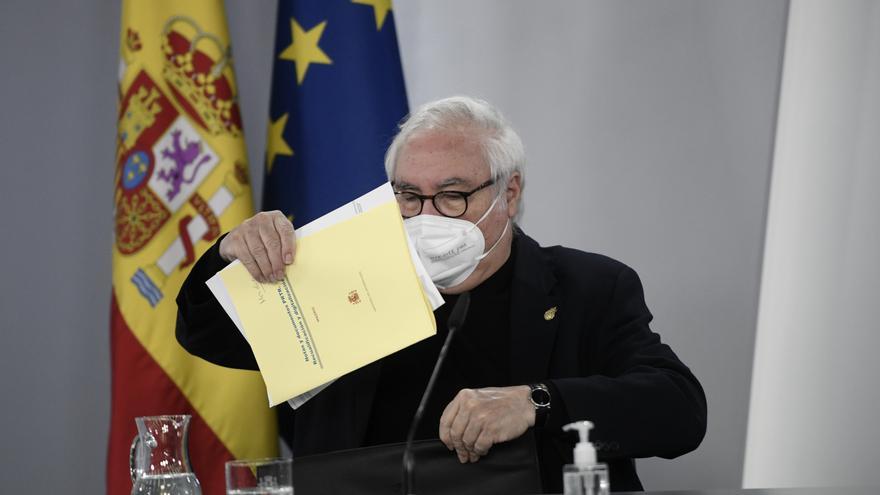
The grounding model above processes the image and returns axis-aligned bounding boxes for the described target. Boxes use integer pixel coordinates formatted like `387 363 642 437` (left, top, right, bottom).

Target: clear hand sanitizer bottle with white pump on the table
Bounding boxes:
562 421 609 495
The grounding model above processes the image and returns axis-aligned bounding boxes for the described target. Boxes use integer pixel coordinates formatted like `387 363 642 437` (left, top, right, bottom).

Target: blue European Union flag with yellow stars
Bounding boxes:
263 0 407 225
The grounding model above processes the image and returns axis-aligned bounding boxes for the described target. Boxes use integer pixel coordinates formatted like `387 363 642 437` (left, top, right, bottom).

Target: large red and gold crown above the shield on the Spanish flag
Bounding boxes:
162 16 241 136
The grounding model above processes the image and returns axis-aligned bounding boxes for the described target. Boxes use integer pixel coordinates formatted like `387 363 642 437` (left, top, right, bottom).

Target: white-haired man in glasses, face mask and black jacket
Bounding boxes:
177 97 706 491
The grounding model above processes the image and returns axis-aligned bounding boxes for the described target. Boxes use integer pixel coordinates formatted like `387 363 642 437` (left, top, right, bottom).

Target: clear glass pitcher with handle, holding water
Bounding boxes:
128 414 202 495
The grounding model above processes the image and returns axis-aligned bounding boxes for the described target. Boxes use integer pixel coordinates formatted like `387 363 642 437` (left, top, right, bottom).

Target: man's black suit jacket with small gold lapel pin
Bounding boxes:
177 230 706 492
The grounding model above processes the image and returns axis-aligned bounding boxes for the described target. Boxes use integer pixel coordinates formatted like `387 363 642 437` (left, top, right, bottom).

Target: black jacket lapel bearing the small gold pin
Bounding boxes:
510 229 565 384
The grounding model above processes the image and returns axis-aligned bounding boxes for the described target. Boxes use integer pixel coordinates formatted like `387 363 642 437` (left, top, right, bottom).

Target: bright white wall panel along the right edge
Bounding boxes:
744 0 880 487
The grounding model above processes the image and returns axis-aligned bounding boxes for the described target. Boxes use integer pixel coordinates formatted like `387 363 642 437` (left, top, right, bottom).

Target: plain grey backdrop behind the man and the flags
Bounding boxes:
0 0 786 493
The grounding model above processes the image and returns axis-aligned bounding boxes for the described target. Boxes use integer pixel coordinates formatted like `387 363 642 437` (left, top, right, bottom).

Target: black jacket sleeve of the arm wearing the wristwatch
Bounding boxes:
552 265 706 459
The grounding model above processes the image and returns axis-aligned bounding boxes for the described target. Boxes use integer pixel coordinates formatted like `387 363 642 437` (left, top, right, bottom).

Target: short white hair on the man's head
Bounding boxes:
385 96 526 208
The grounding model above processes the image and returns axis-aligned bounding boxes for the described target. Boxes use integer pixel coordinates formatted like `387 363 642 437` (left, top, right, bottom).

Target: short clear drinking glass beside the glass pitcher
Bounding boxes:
226 459 293 495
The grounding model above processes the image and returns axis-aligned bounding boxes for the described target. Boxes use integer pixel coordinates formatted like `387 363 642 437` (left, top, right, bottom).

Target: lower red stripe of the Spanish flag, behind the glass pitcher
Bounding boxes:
107 295 232 495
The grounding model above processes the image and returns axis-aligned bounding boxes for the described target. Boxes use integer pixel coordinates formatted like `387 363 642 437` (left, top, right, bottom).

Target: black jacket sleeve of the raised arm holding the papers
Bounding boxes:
176 237 258 370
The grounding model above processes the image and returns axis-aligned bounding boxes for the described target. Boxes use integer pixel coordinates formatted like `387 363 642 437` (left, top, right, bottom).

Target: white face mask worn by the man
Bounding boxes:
403 195 510 289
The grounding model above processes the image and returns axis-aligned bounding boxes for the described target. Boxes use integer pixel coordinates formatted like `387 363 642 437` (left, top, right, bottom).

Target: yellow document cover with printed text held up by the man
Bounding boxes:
219 201 436 406
